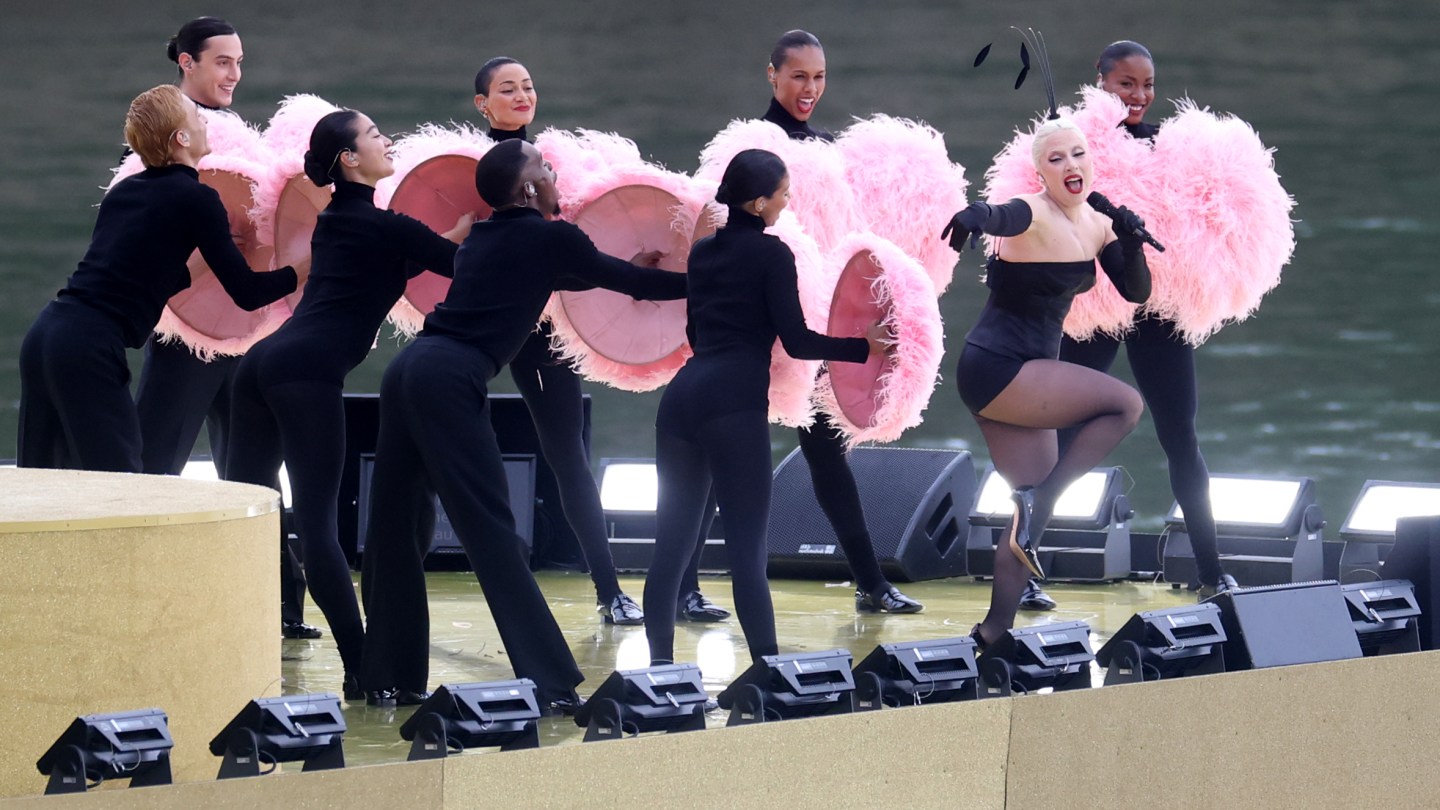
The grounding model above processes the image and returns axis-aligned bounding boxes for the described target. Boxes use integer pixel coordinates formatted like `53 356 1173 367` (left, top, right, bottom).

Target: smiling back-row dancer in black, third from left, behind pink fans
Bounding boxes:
680 30 924 621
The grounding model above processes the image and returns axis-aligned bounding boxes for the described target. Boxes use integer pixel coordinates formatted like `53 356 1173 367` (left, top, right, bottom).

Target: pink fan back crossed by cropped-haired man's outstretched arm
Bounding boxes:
560 184 691 365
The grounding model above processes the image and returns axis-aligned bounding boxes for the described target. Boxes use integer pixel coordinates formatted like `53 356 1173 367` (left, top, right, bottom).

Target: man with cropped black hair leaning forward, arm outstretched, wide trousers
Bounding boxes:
364 140 685 711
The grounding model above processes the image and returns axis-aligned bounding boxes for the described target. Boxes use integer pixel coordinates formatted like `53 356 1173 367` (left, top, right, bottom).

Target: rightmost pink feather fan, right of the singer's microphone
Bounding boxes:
1142 99 1295 346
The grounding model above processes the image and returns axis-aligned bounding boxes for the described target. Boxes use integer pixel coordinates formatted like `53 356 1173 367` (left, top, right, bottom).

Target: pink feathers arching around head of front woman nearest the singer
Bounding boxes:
696 120 864 252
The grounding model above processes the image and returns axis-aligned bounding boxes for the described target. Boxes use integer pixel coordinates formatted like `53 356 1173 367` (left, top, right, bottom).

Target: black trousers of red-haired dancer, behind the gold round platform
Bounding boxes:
17 298 140 473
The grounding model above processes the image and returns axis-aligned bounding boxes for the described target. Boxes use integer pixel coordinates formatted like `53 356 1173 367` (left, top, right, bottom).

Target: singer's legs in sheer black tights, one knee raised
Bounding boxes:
975 360 1143 641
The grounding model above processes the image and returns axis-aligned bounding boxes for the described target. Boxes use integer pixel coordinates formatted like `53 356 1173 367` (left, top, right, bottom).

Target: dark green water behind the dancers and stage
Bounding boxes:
0 0 1440 527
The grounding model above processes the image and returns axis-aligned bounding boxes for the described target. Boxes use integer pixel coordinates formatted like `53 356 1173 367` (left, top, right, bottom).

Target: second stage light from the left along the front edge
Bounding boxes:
210 692 346 780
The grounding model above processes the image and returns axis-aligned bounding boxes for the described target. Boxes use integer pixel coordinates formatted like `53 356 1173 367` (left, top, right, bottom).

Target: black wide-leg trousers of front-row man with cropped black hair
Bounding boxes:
361 337 585 702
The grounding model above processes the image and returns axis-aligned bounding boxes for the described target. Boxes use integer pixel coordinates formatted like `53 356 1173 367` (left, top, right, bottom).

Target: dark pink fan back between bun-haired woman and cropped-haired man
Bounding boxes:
390 154 491 316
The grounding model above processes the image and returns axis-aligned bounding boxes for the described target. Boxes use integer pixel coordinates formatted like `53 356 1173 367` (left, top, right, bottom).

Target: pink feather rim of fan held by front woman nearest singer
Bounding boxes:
815 232 945 447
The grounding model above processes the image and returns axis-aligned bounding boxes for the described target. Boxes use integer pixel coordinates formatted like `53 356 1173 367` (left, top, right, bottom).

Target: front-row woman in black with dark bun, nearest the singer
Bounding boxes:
645 150 884 664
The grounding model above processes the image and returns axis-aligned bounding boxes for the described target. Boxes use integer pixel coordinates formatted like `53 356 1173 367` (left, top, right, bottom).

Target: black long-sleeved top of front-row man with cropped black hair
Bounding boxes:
420 208 685 373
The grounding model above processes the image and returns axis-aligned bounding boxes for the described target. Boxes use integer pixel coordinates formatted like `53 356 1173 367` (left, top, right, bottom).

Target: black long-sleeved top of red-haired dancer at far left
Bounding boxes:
58 164 295 349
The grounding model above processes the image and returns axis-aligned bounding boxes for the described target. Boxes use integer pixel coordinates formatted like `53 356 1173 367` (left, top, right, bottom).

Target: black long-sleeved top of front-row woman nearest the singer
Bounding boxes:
657 208 870 430
